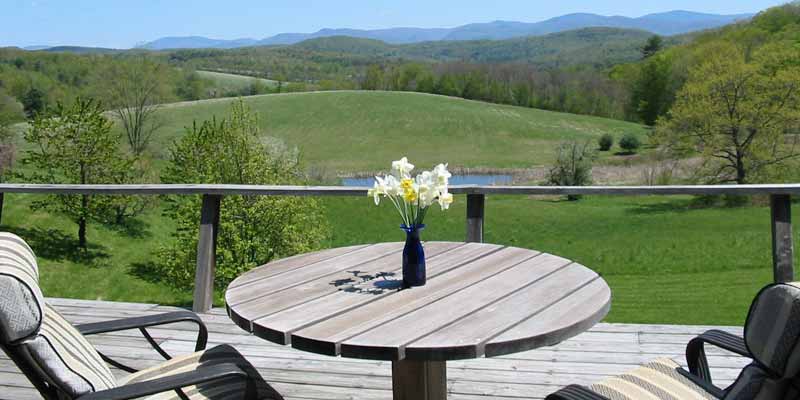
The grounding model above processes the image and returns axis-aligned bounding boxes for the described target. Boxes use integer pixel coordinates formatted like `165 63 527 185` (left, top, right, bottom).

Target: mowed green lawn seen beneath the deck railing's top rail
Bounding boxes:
2 190 788 325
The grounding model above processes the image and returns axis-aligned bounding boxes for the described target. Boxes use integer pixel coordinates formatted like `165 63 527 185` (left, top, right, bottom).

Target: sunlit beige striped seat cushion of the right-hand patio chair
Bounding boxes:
589 358 716 400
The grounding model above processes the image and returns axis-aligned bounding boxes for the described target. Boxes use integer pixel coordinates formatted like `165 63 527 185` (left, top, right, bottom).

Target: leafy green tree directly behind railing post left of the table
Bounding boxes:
156 101 327 287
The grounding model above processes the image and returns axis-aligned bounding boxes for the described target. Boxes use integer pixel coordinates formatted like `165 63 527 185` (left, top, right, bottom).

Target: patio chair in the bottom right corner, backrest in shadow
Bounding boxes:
546 282 800 400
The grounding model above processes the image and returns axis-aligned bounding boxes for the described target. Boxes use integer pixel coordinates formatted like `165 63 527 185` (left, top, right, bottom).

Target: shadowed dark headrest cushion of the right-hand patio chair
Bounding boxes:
744 283 800 378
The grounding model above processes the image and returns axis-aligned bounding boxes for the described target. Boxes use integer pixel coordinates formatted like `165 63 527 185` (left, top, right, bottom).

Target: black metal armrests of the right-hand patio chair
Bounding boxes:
546 329 753 400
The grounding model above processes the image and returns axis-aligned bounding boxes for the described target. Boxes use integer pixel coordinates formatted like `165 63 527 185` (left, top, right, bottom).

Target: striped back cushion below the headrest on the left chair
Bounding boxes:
22 305 116 397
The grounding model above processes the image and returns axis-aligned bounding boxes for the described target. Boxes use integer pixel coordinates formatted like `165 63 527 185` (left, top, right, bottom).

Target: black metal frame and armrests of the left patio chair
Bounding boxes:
3 311 258 400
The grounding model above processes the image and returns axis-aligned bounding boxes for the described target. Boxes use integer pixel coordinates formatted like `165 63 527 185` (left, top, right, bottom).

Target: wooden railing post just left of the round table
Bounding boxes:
192 194 222 313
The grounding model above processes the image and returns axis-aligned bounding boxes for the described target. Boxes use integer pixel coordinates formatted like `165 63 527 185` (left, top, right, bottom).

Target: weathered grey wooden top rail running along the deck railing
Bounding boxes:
0 183 800 196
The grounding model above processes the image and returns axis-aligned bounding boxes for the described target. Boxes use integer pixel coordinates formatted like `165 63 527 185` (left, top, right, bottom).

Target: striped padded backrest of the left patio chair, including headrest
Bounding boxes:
0 232 116 398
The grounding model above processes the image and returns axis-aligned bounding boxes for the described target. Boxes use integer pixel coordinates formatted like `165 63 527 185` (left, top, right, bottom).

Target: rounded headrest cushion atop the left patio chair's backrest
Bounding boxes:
0 232 44 344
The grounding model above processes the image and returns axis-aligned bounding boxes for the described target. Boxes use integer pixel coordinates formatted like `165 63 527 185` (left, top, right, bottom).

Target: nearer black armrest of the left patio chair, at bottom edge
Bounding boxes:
77 364 256 400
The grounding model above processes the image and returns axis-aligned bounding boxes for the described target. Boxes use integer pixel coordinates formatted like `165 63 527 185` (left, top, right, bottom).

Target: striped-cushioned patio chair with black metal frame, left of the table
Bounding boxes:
0 232 282 400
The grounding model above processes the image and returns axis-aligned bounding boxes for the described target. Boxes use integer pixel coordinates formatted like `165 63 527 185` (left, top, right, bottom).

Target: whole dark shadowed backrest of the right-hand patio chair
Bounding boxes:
725 282 800 400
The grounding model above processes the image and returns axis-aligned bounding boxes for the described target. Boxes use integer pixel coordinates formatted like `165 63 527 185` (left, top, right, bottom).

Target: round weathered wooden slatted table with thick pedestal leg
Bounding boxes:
225 242 611 400
